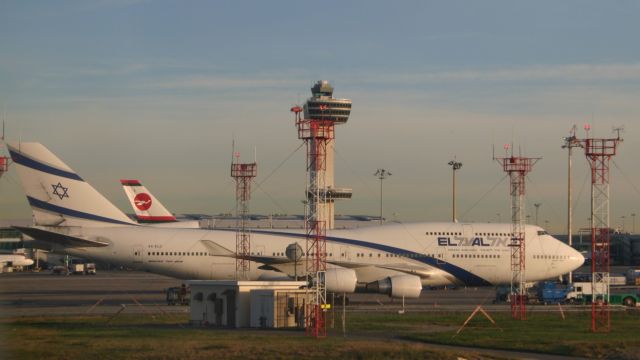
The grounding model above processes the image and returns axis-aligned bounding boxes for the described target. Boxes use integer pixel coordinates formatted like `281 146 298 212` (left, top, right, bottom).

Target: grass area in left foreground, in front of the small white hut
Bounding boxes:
0 315 480 359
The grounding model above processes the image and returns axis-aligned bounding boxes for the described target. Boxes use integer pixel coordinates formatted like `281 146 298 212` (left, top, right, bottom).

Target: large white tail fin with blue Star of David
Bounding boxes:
8 143 135 226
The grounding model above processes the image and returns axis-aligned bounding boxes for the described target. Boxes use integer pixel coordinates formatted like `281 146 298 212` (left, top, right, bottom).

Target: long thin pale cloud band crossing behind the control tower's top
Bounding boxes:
126 63 640 92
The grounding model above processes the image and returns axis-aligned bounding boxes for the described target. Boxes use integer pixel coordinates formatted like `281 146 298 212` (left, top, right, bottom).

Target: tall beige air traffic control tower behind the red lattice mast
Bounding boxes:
304 80 352 229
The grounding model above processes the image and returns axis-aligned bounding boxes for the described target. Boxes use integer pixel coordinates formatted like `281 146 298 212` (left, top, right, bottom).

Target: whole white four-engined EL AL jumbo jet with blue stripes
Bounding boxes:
8 143 584 298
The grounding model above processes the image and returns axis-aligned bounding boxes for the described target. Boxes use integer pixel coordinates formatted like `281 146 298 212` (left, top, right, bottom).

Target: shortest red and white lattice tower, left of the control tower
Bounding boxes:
231 153 258 280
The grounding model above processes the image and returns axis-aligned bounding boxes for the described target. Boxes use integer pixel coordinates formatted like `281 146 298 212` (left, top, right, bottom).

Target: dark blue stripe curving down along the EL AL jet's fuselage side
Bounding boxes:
233 230 491 286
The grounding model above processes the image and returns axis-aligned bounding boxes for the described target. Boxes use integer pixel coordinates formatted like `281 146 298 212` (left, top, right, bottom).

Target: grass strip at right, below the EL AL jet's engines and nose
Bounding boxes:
349 311 640 359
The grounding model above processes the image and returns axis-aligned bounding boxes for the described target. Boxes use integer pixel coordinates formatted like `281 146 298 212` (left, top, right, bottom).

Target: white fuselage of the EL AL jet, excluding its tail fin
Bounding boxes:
37 223 584 286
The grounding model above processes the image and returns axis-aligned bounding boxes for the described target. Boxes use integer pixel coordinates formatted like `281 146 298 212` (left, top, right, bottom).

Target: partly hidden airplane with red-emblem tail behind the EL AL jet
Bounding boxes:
120 179 200 229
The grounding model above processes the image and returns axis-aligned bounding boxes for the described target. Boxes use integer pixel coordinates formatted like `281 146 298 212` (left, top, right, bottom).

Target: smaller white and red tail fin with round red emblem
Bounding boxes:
120 180 176 223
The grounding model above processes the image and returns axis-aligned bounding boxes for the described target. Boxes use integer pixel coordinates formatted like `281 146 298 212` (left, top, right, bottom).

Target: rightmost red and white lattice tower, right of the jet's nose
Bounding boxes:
580 125 622 332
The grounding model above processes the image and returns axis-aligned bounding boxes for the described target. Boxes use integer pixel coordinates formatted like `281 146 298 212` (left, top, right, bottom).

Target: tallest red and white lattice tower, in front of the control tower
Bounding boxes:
291 106 335 337
